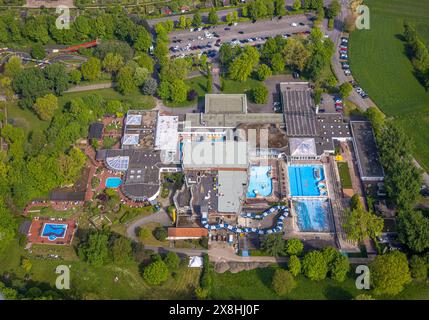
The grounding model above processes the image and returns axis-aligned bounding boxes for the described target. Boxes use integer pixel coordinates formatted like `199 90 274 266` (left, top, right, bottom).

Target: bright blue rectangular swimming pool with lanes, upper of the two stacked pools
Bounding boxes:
288 165 328 197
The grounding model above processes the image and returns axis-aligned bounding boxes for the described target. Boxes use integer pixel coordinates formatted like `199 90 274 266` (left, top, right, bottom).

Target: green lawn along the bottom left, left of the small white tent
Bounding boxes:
0 241 200 299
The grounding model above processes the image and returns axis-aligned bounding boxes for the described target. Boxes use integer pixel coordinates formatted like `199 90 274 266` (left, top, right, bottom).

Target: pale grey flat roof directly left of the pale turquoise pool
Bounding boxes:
217 171 247 213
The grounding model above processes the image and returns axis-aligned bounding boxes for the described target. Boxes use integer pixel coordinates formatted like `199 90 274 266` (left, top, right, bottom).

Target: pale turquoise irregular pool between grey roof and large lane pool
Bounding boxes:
246 166 273 198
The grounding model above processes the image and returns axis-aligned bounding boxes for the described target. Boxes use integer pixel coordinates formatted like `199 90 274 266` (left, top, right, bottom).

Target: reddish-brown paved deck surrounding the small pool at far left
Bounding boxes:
27 218 77 245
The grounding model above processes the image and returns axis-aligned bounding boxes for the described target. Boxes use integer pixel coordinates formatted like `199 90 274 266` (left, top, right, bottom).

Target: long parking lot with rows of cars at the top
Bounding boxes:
169 14 313 56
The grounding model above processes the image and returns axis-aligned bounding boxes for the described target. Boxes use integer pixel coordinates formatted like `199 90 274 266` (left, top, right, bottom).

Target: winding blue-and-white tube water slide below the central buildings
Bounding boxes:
201 206 289 234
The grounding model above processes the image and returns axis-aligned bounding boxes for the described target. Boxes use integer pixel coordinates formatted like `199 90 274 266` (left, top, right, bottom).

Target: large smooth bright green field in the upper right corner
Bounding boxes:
350 0 429 171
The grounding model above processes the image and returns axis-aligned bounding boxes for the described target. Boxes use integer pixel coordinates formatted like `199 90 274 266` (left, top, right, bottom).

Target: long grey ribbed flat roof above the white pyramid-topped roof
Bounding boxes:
280 82 317 136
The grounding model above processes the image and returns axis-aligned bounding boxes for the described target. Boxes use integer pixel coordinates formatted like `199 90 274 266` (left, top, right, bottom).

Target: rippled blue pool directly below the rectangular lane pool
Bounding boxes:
292 199 331 232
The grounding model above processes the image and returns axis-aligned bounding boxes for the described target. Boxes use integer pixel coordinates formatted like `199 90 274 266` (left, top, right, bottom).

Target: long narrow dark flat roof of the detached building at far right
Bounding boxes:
350 121 384 180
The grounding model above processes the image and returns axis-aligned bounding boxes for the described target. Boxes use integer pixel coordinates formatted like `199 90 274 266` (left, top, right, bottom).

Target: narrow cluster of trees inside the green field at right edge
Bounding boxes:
404 23 429 89
